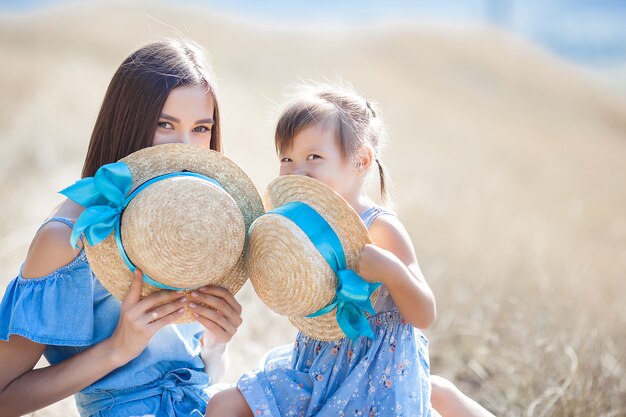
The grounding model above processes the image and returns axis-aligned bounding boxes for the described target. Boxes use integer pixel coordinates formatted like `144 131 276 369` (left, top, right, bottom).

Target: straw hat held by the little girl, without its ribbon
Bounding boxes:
249 175 378 341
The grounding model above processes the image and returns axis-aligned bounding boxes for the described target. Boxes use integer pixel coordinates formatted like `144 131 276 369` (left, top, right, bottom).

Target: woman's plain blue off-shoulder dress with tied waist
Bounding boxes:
0 218 210 417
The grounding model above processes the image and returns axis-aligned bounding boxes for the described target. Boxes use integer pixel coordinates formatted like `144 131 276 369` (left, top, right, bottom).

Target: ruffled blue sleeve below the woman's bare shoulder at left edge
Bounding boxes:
0 252 94 346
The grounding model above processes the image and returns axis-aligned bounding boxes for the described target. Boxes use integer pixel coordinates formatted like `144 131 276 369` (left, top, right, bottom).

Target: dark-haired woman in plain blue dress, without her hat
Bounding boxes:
0 41 241 416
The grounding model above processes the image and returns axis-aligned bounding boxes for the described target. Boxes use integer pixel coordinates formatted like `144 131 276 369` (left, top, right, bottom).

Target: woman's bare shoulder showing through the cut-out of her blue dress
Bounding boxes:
22 221 80 279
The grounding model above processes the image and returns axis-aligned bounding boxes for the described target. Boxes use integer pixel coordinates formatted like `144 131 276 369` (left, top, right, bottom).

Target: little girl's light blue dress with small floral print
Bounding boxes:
237 207 431 417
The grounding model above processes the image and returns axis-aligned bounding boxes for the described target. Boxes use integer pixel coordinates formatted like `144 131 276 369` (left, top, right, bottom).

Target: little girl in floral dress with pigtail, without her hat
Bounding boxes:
207 87 489 417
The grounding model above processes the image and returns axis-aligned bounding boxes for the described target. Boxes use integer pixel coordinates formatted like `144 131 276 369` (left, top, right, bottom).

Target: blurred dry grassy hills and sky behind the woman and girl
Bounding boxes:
0 0 626 417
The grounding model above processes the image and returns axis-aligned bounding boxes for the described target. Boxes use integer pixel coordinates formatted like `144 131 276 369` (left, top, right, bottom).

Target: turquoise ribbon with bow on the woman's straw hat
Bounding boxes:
59 161 224 290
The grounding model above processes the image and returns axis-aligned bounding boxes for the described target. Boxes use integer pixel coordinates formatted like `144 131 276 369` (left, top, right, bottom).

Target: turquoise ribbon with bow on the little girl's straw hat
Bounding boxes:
268 201 381 340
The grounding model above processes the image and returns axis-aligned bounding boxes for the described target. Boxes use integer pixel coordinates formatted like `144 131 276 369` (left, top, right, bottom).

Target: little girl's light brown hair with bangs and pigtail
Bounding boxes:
274 84 388 203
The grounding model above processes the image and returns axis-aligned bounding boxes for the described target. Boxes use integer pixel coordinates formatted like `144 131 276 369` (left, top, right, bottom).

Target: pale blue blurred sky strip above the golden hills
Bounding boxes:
0 0 626 67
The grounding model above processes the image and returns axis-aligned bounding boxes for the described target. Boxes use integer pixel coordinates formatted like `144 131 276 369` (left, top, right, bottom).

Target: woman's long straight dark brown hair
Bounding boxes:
82 40 222 178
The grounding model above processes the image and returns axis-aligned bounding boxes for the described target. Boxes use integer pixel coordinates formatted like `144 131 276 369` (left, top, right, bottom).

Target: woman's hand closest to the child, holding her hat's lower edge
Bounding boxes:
189 285 243 344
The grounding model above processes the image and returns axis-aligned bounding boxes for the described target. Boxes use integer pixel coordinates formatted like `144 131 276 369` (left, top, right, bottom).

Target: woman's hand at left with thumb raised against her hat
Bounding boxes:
109 269 187 366
